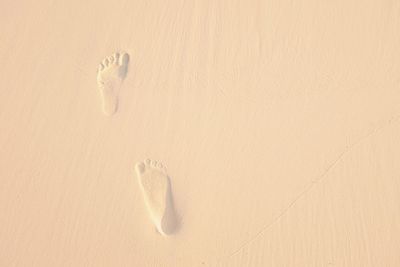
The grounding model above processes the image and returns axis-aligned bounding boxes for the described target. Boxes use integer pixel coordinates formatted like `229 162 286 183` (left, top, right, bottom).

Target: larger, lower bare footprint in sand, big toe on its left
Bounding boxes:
135 159 177 235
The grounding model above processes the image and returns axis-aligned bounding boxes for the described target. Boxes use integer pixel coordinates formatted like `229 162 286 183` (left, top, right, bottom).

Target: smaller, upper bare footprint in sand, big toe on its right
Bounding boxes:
97 53 129 116
